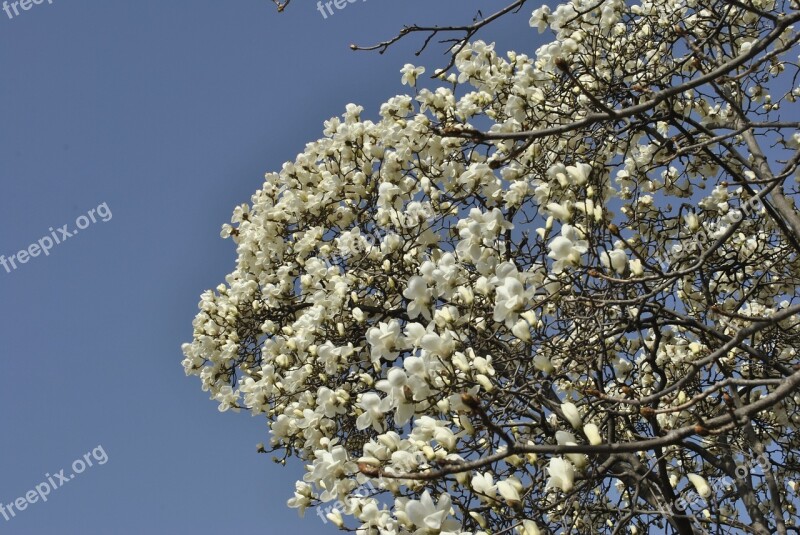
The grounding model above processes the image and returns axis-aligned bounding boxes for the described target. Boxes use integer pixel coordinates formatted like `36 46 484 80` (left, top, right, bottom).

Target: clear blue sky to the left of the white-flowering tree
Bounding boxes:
0 0 536 535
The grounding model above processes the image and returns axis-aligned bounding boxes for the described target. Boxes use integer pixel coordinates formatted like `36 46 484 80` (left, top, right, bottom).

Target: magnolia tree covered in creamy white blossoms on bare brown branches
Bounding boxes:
183 0 800 535
